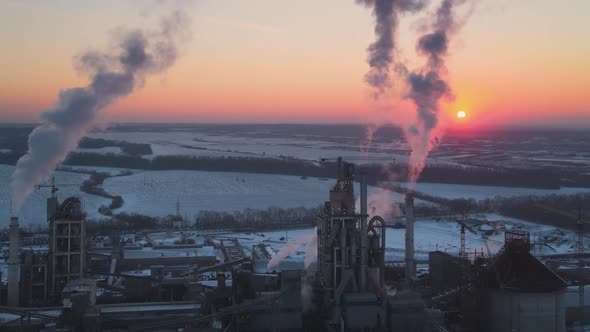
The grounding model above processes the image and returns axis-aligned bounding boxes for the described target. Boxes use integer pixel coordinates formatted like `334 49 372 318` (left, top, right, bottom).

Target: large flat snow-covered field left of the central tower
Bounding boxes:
103 171 333 218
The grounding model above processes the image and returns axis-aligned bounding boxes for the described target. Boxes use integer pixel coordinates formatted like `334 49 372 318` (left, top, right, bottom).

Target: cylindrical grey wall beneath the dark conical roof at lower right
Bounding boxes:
482 290 565 332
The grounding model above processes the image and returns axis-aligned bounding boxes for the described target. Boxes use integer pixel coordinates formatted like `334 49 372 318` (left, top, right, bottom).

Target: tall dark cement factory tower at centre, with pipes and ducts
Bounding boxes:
317 158 385 329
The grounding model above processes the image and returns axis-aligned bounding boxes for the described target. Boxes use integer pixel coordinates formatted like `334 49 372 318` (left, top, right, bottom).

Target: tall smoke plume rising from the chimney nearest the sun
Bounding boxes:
398 0 473 186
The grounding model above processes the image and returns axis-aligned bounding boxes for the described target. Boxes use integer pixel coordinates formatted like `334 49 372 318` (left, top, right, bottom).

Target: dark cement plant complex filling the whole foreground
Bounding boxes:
0 159 588 332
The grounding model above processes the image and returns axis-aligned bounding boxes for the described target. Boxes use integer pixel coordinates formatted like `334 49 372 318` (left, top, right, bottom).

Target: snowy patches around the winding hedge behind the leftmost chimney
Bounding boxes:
0 165 110 227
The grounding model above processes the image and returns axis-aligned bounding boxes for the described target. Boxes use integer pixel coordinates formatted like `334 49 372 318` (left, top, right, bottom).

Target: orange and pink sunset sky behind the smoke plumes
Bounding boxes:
0 0 590 127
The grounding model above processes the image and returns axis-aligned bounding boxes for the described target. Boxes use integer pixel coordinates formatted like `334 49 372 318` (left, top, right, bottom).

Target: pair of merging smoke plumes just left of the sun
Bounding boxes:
356 0 474 188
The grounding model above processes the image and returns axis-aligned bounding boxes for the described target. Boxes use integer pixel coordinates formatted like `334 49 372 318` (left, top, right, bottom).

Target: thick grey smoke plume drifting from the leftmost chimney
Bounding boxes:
11 11 190 213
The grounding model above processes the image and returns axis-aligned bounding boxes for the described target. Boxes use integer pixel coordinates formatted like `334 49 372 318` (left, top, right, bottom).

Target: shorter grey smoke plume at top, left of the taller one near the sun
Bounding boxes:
356 0 428 98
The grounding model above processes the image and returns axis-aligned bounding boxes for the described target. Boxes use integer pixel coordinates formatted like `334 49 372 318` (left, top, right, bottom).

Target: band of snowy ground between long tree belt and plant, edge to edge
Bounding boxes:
0 165 587 224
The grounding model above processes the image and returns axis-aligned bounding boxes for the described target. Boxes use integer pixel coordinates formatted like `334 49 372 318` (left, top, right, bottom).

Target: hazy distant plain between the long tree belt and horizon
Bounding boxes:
0 124 590 187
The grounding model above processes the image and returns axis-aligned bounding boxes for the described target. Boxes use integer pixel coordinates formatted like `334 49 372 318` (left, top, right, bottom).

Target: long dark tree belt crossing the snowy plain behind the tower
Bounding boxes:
65 153 562 189
